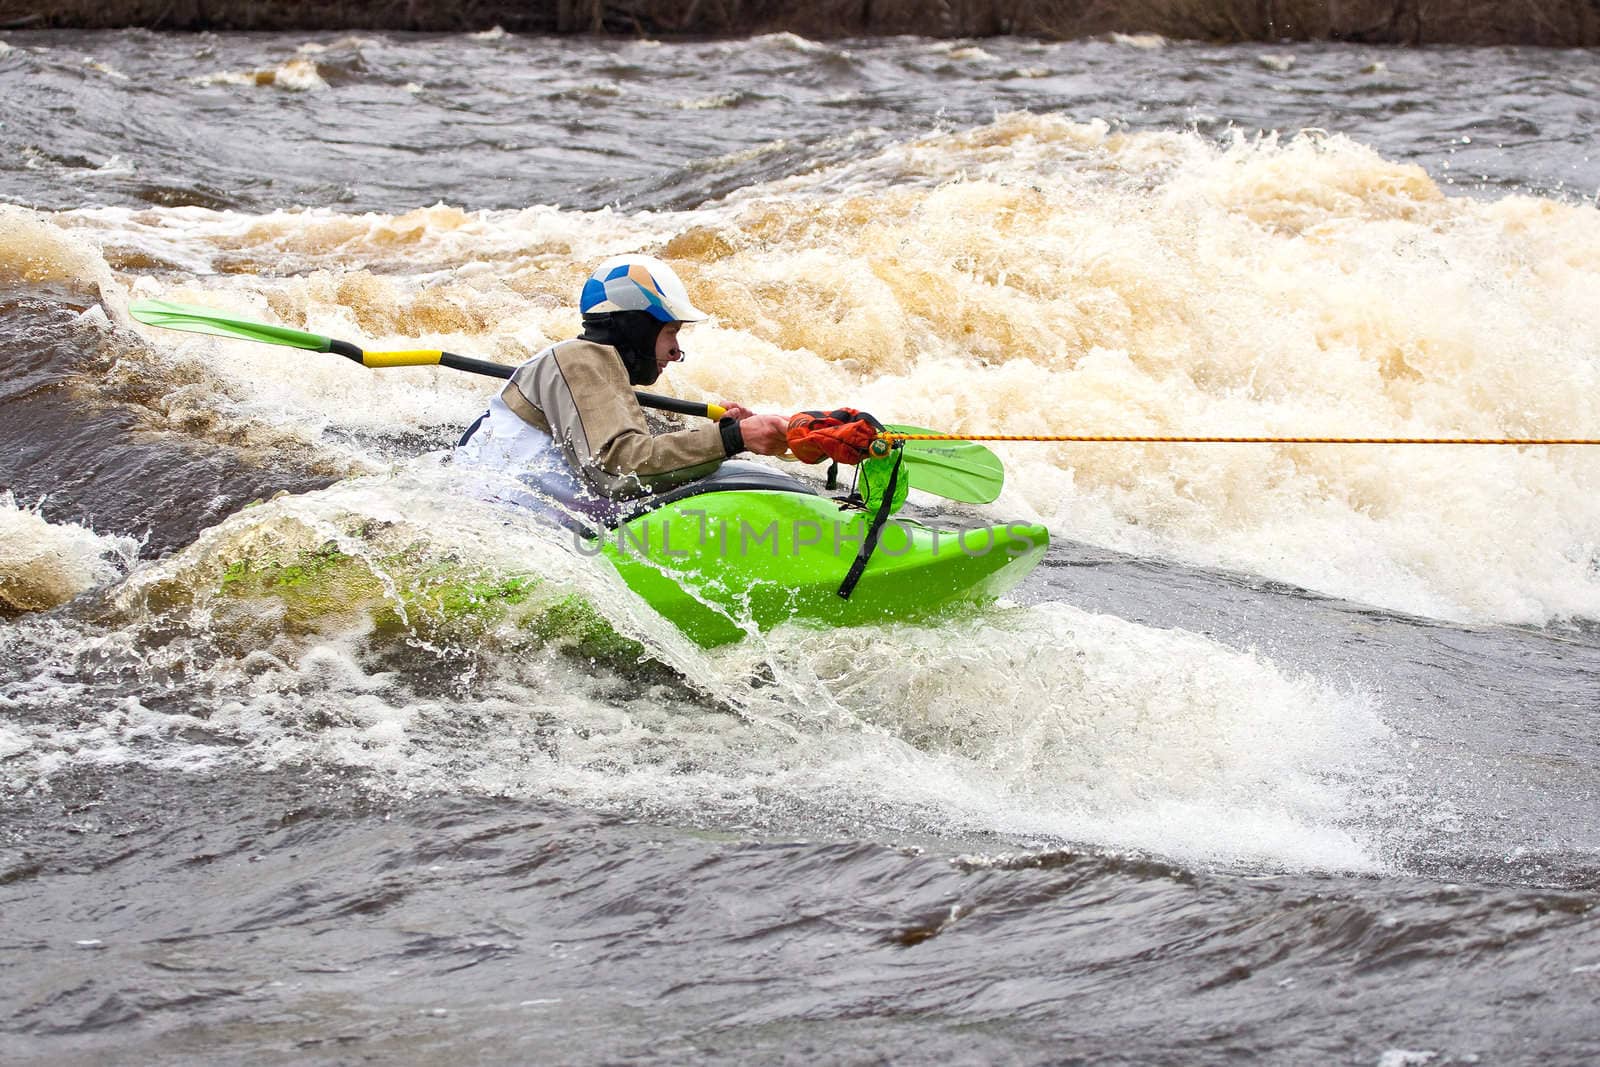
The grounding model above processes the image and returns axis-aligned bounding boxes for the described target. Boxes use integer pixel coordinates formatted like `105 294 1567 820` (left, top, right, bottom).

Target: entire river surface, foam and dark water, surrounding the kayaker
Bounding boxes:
0 24 1600 1067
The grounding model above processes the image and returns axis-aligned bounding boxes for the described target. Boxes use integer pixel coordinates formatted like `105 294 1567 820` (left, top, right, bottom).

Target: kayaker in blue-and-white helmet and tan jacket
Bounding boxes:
458 254 789 518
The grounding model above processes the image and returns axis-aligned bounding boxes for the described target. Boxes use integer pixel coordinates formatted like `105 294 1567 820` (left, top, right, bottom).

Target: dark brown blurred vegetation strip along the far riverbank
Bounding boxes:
0 0 1600 46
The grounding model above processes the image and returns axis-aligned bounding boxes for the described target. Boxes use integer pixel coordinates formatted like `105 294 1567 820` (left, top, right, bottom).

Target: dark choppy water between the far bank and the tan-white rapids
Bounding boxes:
0 32 1600 211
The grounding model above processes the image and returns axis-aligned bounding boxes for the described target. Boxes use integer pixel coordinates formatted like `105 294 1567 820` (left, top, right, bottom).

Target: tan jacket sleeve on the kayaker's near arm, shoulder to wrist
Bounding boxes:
501 341 726 498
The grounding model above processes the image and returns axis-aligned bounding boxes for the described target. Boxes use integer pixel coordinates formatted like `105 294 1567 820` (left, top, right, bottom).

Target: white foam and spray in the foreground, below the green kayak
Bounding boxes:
0 461 1386 869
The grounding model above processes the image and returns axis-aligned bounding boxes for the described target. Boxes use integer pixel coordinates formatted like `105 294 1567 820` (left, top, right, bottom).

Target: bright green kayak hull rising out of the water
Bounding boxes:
594 490 1050 646
